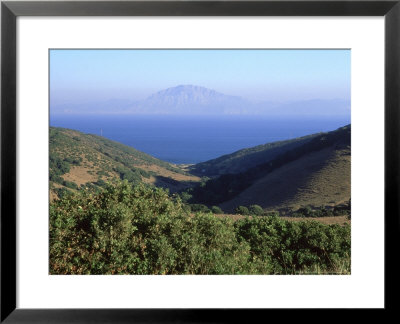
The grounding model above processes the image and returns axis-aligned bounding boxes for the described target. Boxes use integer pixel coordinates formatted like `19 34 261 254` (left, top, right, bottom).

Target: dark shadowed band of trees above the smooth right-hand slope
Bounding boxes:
185 125 351 205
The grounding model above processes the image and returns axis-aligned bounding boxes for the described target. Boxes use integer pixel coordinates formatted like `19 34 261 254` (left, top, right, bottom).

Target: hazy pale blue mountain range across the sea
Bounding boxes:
51 85 350 116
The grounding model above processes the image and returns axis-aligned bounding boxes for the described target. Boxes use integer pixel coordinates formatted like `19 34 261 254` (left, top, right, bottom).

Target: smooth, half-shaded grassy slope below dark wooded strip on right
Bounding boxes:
221 147 351 211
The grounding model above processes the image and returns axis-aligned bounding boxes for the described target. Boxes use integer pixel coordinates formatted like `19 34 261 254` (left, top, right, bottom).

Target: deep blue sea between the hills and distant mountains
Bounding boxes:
50 115 350 164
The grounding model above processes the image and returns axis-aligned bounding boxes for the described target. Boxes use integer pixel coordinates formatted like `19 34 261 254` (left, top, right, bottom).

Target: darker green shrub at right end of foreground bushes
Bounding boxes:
236 217 350 274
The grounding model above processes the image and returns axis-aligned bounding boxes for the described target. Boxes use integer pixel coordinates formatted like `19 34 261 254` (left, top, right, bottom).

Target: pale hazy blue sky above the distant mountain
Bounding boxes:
50 50 350 104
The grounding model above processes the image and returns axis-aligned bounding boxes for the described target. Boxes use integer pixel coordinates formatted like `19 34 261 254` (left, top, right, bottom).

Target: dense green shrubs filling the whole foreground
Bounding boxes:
49 181 350 274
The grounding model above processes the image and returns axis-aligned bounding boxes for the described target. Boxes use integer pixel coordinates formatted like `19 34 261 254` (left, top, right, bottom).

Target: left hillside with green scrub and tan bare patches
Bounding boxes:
49 127 199 199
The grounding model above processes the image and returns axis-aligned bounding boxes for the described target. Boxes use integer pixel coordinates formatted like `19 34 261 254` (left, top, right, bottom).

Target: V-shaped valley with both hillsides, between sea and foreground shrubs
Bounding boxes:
49 125 351 216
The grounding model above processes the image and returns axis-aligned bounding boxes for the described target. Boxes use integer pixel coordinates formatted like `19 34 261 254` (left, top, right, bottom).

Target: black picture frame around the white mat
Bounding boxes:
0 0 400 323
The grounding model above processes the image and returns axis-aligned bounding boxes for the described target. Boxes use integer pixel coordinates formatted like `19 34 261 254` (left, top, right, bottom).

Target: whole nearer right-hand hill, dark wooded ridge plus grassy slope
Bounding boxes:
185 125 351 212
